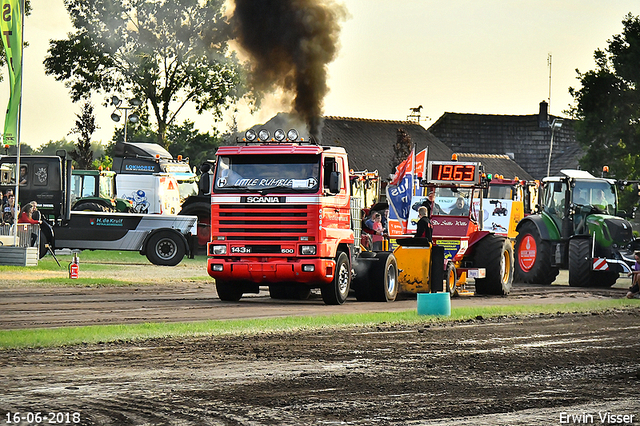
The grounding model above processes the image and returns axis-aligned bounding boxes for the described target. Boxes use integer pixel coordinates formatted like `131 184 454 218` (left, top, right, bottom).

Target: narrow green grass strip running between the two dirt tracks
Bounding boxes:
0 299 640 349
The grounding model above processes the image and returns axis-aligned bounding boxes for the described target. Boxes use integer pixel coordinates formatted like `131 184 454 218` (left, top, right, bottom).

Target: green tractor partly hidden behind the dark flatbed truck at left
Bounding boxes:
71 170 134 213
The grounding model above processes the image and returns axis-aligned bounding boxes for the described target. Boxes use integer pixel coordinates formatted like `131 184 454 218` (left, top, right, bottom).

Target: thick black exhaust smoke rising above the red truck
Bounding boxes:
231 0 346 140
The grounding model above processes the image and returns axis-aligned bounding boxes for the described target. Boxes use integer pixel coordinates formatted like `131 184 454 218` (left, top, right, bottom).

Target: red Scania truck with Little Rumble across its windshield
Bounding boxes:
207 130 398 304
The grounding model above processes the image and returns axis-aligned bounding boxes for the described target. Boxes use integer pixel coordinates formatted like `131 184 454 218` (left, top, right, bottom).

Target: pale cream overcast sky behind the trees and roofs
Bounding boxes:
0 0 640 147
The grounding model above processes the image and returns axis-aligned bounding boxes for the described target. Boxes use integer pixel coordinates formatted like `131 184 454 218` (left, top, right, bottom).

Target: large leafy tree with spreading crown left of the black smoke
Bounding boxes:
44 0 245 148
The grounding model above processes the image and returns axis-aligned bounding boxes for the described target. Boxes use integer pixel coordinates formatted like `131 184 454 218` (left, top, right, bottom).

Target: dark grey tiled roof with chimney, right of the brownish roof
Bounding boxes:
429 101 583 179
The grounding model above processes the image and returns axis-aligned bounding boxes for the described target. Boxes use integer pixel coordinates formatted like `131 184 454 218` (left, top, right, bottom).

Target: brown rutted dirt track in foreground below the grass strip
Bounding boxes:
0 308 640 425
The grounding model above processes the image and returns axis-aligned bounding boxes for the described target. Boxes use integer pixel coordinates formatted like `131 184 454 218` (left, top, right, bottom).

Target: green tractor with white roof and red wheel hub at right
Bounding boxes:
515 170 640 287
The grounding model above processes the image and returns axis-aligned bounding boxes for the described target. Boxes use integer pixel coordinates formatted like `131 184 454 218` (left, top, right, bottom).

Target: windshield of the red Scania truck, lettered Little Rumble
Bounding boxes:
213 155 320 192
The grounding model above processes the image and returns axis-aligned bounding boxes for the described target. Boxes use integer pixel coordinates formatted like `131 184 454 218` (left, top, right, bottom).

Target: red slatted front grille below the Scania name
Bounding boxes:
211 204 317 241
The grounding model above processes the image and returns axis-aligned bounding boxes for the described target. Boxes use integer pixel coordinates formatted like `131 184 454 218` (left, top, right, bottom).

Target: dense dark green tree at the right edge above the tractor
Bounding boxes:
568 14 640 179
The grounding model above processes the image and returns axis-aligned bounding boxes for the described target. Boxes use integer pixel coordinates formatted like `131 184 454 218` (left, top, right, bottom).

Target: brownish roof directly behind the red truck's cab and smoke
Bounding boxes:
241 113 453 177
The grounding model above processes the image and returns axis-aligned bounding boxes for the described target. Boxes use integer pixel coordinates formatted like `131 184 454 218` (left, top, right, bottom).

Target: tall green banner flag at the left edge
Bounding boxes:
0 0 22 145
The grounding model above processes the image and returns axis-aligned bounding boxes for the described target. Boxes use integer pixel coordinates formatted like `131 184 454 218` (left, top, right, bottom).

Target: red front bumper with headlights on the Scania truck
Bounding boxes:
207 257 336 285
